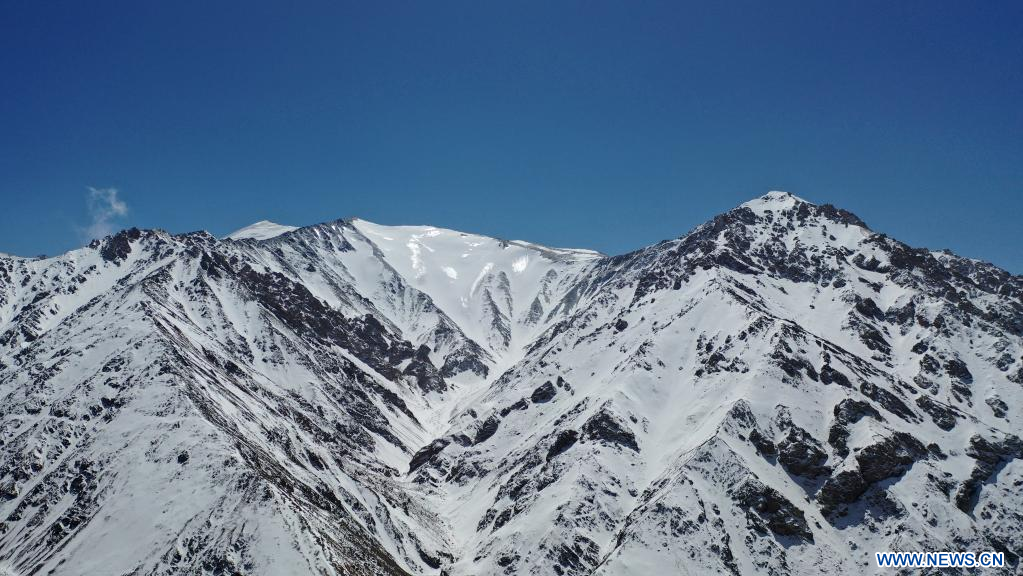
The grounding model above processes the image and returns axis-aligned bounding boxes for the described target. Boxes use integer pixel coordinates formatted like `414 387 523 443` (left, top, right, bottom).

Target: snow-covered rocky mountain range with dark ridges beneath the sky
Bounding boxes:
0 192 1023 576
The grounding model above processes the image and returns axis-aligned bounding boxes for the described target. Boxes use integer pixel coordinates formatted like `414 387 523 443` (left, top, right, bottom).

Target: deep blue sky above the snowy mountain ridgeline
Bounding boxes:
0 0 1023 273
